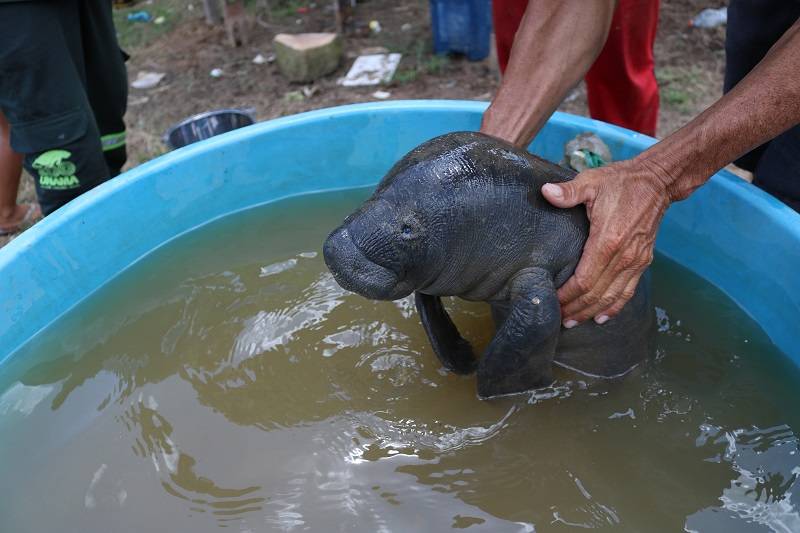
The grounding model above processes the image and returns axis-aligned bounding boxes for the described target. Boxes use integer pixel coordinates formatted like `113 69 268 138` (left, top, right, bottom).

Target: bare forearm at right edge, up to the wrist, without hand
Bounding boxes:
634 21 800 201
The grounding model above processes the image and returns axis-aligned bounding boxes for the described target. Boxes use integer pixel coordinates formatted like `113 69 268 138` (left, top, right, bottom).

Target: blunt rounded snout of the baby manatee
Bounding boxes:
322 226 414 300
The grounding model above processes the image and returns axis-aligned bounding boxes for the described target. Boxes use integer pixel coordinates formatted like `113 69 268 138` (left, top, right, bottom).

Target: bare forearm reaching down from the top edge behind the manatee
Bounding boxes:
481 0 616 146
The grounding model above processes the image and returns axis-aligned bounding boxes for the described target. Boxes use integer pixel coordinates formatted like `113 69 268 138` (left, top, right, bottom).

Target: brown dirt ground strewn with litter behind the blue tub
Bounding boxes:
0 0 725 246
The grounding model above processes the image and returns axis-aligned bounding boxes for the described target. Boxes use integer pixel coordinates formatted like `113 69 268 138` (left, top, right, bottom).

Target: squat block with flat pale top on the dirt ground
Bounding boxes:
272 33 342 81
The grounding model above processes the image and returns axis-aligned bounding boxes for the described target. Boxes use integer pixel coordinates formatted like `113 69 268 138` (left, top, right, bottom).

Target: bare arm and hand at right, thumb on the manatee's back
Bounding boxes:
542 21 800 327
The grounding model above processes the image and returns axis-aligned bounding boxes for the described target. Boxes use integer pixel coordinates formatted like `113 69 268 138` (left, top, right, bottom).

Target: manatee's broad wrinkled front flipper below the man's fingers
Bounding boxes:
478 268 561 398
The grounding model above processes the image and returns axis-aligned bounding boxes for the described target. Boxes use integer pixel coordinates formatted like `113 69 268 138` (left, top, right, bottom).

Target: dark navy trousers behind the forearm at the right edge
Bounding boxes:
724 0 800 211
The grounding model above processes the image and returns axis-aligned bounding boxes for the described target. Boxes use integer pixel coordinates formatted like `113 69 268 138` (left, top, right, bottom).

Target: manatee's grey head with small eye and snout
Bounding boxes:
323 190 438 300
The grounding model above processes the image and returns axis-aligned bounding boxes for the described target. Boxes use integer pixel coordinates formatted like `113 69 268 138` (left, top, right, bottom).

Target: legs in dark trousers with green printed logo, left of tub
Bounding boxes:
0 0 128 215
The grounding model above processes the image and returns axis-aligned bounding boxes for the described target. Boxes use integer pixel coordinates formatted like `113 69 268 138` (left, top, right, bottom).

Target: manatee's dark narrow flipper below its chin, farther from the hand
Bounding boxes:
414 292 476 374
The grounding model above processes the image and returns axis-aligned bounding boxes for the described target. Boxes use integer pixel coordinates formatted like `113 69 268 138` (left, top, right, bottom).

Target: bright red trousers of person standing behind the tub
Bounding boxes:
492 0 659 136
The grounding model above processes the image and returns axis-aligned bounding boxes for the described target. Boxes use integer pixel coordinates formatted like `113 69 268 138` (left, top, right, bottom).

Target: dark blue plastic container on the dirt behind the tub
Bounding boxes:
431 0 492 61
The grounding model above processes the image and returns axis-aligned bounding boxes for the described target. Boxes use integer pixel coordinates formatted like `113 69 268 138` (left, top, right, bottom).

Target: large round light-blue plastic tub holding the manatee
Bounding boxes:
0 101 800 371
